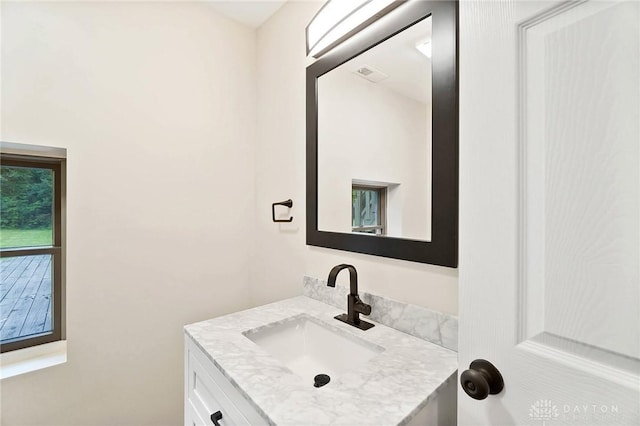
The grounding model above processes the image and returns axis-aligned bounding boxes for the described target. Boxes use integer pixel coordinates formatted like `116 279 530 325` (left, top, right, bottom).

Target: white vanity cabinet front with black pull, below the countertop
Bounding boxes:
184 336 268 426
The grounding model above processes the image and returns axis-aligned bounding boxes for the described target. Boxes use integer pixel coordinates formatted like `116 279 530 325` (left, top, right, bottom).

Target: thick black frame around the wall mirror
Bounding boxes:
306 0 458 268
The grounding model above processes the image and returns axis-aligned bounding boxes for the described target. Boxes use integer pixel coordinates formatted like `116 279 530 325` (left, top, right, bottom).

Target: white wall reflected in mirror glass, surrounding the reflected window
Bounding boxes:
318 64 431 241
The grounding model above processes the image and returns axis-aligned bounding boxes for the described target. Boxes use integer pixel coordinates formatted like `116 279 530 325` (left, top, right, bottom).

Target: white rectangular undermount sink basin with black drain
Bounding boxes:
243 314 384 384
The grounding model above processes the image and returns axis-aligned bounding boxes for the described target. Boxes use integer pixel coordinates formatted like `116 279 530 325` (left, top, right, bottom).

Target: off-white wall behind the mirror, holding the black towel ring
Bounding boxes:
251 1 458 313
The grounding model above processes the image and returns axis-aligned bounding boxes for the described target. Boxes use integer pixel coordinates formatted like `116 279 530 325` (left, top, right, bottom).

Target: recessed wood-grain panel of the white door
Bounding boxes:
519 2 640 359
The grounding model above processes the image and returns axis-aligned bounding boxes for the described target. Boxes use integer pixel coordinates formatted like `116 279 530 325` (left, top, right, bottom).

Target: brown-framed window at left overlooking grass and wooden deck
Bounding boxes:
0 143 66 352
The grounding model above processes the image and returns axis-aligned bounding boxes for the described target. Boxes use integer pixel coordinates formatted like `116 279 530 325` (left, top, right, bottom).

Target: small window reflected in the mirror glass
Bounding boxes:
351 185 387 235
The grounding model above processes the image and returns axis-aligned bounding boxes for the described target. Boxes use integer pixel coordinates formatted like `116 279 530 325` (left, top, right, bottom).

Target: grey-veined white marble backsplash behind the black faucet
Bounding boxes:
302 276 458 351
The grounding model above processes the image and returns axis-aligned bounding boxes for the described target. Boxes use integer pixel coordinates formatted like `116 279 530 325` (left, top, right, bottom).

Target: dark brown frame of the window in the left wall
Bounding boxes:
0 153 66 353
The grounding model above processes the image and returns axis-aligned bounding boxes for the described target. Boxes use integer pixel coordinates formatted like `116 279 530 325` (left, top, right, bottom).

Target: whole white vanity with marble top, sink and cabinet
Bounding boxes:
184 296 458 426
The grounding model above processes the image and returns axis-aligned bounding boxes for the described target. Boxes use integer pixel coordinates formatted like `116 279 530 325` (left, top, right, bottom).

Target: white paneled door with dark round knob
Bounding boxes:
458 0 640 426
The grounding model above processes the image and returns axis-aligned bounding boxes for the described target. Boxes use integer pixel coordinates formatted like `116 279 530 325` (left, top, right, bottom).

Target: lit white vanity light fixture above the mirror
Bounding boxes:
306 0 407 58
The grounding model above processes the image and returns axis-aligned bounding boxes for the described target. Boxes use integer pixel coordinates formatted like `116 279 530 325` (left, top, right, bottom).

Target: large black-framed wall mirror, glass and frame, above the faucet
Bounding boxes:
306 0 458 267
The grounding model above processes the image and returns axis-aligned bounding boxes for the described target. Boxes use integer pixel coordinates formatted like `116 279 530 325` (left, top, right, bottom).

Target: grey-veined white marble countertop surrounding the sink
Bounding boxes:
185 296 457 426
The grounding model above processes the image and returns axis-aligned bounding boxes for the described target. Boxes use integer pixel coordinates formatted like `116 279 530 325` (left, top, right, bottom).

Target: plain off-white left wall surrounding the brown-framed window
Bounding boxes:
1 2 258 425
